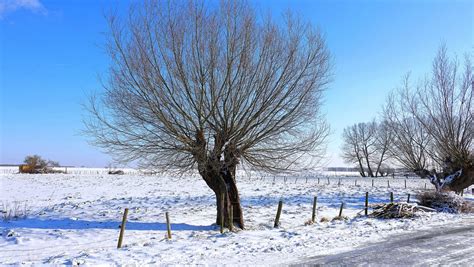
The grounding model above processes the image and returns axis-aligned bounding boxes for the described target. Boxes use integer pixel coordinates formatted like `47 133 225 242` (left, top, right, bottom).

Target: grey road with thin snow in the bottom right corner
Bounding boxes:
295 220 474 266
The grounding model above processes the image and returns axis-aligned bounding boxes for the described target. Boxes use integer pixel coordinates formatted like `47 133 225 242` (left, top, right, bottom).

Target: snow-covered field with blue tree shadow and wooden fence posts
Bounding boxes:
0 171 472 265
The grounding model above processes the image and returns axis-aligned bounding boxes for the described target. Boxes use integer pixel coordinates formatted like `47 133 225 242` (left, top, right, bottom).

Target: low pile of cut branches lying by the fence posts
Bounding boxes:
369 203 435 219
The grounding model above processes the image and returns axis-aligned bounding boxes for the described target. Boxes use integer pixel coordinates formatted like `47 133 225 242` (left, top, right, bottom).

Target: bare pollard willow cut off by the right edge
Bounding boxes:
384 46 474 192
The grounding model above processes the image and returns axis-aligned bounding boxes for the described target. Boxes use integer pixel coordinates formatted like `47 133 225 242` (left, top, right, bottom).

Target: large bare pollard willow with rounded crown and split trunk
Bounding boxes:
86 1 331 228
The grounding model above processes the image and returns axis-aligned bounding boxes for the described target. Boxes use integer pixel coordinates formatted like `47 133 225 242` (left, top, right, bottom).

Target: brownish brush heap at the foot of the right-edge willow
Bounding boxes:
418 191 474 213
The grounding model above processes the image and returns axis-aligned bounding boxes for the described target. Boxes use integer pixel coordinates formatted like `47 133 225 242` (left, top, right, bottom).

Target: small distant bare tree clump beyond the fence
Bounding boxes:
342 121 392 177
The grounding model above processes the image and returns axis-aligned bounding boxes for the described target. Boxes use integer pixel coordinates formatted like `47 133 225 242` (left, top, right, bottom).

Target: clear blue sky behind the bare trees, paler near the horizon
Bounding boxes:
0 0 474 167
